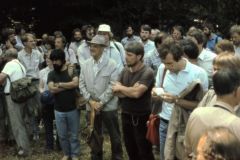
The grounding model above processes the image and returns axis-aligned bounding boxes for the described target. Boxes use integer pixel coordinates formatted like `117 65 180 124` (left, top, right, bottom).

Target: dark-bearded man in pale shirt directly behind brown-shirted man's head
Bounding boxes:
121 25 141 46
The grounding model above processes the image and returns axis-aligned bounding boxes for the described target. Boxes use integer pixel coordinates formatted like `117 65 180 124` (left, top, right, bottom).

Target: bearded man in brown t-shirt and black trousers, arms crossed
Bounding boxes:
112 42 154 160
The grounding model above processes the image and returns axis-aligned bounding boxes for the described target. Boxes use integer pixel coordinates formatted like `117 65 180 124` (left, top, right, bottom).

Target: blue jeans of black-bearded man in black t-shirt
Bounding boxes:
54 109 80 157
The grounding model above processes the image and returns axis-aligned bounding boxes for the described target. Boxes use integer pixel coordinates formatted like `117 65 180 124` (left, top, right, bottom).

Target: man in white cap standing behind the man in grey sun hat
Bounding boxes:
97 24 126 73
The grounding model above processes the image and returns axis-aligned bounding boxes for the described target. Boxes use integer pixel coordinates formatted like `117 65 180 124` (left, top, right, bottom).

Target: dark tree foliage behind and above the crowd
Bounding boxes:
0 0 240 35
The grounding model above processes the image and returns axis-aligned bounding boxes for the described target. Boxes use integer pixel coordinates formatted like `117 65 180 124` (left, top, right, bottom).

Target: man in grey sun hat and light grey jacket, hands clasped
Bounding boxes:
79 35 122 160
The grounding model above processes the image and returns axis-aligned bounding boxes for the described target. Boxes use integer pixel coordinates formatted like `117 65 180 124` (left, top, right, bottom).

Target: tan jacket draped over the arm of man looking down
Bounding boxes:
164 81 204 160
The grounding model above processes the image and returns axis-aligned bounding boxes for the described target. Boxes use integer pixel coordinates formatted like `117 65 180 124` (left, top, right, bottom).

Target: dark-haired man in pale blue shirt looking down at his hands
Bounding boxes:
156 42 207 159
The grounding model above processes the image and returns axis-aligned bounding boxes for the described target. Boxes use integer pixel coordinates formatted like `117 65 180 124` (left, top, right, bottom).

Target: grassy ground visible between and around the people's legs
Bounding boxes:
0 110 159 160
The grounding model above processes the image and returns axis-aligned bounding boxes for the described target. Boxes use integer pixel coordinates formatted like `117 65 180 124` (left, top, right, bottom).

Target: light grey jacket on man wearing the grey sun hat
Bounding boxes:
79 57 119 111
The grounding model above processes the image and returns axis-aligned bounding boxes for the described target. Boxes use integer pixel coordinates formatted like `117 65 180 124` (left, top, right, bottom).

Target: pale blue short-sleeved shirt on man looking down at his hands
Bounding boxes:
156 59 208 120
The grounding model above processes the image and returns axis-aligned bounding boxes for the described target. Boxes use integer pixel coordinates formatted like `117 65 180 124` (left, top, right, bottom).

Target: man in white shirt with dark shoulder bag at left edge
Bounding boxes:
0 49 31 156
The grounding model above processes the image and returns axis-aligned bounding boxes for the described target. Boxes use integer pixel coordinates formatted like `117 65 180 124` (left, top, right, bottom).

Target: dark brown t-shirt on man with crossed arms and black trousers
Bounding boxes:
119 66 154 114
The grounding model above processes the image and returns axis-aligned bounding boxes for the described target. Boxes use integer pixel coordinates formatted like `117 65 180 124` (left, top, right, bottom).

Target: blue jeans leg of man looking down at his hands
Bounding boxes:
159 118 168 160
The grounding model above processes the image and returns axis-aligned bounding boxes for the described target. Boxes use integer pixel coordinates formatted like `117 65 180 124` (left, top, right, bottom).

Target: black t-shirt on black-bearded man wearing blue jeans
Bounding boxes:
47 70 77 112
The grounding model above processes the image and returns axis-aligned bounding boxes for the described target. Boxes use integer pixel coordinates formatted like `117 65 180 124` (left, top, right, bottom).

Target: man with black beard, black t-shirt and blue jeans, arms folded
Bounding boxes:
47 49 80 160
